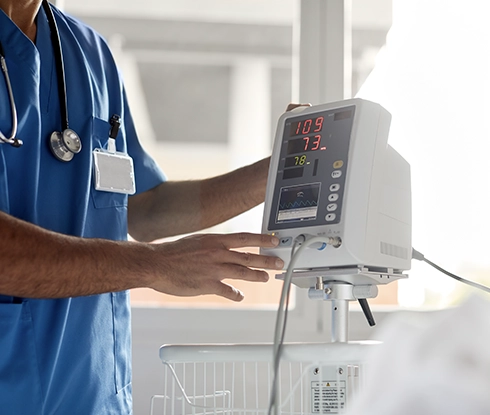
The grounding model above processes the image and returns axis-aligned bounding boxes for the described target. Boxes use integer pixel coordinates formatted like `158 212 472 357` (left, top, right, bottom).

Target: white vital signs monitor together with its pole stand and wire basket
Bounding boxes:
154 99 412 415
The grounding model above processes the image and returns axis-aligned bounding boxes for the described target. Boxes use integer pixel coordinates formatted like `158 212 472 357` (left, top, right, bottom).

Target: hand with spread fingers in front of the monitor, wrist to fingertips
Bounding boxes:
148 233 284 301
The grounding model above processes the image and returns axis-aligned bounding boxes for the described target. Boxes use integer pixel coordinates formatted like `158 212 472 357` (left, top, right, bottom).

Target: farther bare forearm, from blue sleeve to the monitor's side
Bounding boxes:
128 158 269 241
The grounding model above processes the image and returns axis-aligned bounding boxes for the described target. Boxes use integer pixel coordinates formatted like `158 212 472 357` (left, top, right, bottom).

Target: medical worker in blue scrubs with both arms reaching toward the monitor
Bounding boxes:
0 0 283 415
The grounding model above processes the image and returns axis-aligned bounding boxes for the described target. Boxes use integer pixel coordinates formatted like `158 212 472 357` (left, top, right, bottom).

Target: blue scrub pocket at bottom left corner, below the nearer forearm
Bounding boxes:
0 302 43 415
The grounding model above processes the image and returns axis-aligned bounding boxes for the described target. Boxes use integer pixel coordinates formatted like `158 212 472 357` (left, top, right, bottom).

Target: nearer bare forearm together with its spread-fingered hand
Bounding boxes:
0 212 284 301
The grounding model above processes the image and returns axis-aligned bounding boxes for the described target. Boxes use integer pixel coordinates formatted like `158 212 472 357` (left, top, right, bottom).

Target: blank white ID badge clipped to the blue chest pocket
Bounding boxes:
93 148 136 195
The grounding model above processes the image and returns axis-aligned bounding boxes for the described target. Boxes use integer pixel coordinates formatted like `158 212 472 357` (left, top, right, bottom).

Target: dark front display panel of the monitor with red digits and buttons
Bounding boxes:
268 105 355 231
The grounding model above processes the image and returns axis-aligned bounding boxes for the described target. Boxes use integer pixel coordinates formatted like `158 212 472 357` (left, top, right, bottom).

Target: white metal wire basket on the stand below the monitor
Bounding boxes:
151 342 377 415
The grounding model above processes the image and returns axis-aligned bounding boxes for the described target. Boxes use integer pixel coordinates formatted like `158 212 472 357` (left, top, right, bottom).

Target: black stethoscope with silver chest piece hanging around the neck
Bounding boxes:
0 0 82 161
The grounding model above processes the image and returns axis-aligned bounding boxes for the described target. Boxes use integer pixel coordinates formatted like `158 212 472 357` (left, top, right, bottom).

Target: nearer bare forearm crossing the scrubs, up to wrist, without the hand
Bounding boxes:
0 213 153 298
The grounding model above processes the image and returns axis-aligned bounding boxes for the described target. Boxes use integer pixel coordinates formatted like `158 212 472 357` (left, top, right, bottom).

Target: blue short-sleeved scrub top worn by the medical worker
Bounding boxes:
0 4 165 415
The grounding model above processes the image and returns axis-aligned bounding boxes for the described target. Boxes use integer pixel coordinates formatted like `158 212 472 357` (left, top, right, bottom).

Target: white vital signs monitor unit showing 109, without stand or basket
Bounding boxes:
262 99 412 280
